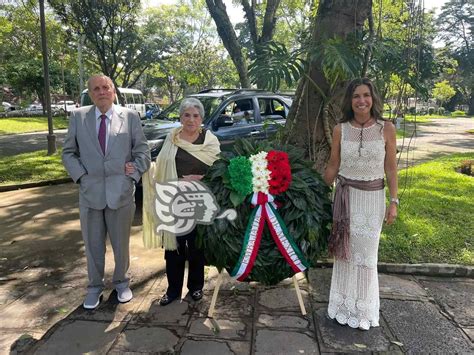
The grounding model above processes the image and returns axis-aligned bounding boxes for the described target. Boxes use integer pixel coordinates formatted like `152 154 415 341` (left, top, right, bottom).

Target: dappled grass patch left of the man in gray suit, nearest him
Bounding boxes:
0 150 68 185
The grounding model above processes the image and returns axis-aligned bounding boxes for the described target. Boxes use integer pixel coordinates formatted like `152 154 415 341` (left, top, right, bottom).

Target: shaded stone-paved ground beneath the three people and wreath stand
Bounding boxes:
0 184 474 354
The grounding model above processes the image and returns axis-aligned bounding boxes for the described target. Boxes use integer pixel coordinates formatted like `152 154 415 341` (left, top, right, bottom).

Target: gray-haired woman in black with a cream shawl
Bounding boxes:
143 98 220 306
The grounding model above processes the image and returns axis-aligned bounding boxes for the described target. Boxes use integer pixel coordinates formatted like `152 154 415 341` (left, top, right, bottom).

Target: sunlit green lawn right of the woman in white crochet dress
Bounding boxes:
379 153 474 265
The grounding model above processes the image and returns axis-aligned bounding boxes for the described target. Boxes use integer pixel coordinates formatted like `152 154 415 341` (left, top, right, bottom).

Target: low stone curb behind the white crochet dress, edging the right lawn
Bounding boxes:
316 260 474 279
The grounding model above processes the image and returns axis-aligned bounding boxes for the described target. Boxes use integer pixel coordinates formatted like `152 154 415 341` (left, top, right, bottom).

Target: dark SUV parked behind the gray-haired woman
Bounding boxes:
143 89 292 160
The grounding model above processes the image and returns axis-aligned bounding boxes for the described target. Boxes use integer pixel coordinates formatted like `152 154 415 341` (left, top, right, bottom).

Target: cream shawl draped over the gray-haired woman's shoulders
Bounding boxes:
142 127 221 250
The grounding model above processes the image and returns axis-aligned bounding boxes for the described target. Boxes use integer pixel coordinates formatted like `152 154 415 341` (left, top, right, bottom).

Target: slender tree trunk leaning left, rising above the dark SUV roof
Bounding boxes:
206 0 250 88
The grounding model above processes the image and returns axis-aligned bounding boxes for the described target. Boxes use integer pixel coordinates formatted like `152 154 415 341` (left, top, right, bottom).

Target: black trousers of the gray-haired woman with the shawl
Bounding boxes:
165 229 205 298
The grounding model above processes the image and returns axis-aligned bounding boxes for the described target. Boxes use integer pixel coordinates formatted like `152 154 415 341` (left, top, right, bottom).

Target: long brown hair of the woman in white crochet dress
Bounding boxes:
341 78 383 122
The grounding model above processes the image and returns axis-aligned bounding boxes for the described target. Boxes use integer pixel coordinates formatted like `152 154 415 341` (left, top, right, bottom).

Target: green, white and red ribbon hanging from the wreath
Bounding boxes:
230 192 309 281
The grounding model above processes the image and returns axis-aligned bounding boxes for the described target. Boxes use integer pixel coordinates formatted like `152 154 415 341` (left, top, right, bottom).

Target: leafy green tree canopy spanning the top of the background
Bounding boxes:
0 0 474 117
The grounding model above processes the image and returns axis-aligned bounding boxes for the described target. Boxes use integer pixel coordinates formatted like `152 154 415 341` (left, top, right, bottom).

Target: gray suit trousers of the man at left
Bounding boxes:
79 202 135 293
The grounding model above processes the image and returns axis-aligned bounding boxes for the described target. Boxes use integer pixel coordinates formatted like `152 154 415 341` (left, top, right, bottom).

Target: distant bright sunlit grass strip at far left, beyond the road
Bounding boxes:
0 116 69 135
